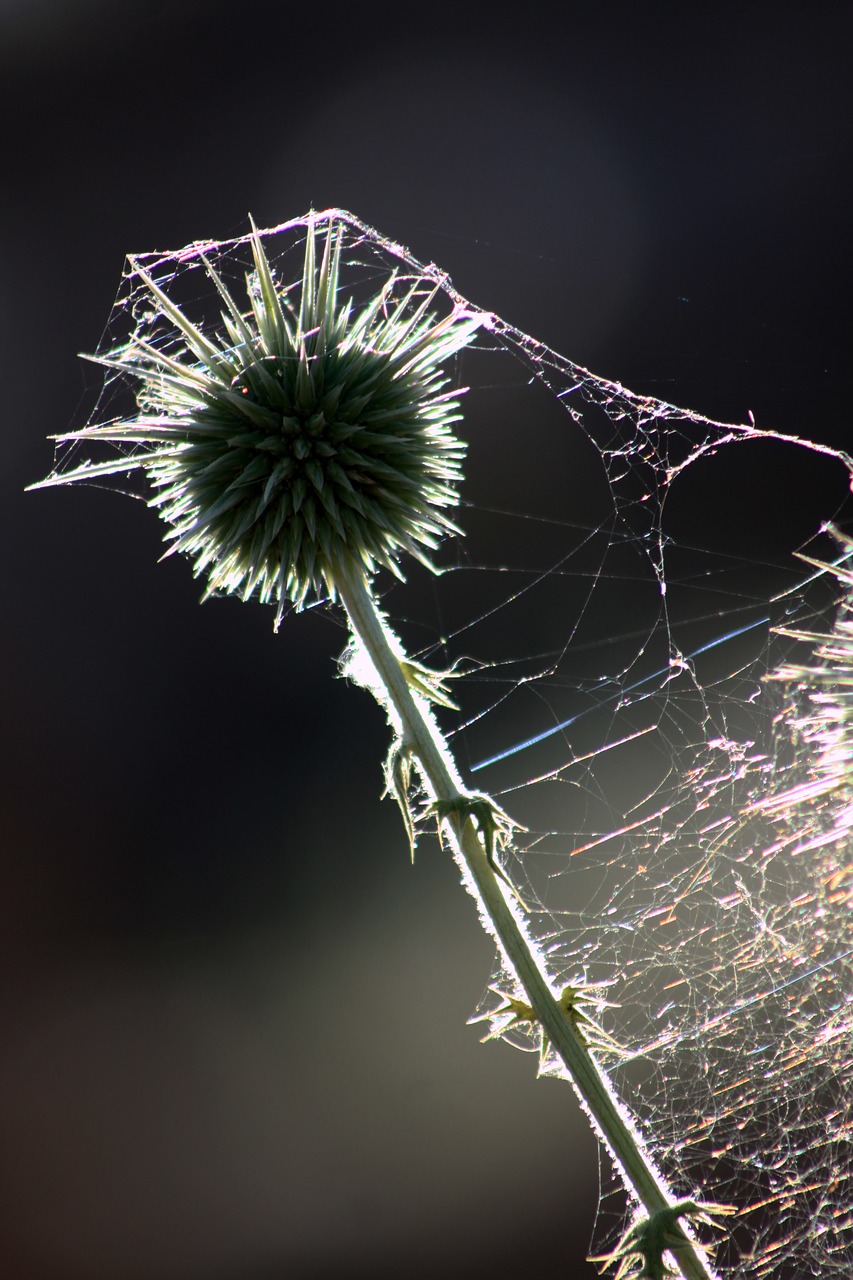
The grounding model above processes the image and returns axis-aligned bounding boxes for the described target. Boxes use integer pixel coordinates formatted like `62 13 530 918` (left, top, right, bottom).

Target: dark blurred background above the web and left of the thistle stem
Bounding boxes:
0 0 853 1280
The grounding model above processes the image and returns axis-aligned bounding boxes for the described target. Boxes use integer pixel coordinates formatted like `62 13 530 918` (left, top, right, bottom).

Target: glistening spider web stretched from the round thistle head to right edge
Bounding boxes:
48 210 853 1280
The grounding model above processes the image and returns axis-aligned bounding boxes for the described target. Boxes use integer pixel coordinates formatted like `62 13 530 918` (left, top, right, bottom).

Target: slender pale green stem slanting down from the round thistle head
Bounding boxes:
334 562 715 1280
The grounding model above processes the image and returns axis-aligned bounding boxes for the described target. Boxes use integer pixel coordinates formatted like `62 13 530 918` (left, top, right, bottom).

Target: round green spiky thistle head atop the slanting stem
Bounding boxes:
38 219 482 625
